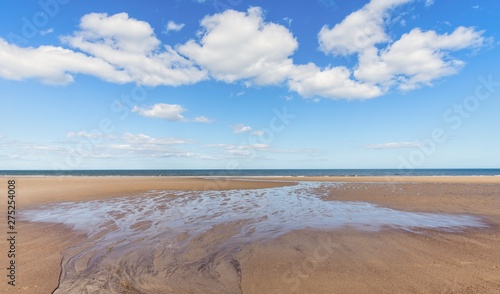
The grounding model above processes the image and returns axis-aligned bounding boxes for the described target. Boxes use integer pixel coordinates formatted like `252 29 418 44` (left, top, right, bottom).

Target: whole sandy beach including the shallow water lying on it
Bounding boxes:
0 176 500 293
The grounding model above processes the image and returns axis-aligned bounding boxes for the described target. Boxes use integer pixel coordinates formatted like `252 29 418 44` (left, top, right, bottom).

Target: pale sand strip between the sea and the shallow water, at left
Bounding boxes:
8 177 294 207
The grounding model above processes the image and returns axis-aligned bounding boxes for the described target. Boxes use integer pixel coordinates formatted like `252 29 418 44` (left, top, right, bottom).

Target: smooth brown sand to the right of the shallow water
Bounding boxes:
237 177 500 293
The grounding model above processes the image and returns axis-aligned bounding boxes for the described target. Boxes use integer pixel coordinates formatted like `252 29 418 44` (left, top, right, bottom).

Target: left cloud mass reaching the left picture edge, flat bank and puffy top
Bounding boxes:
0 13 207 86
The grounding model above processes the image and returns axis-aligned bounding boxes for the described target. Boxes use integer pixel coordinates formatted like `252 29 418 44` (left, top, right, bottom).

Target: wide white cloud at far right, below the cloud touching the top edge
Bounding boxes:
354 27 484 90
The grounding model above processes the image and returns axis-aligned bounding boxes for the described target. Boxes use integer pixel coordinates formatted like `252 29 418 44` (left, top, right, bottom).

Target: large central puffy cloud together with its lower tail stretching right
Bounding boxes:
177 7 382 99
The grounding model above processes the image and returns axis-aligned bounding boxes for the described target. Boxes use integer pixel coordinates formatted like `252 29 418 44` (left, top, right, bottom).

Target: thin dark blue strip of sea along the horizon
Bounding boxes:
0 169 500 177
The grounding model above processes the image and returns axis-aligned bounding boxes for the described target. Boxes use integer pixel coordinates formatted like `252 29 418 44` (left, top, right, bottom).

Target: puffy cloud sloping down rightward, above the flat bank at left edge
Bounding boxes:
63 13 206 86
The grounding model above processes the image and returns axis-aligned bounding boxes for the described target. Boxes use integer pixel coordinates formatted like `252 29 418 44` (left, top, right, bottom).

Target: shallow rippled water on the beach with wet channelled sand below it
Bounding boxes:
23 183 485 293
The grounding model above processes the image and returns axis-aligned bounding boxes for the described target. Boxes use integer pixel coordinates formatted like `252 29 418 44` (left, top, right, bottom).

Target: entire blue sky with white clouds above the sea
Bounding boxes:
0 0 500 170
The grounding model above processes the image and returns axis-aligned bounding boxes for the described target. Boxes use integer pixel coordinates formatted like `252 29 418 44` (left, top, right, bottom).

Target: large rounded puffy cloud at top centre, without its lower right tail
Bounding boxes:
177 7 298 85
